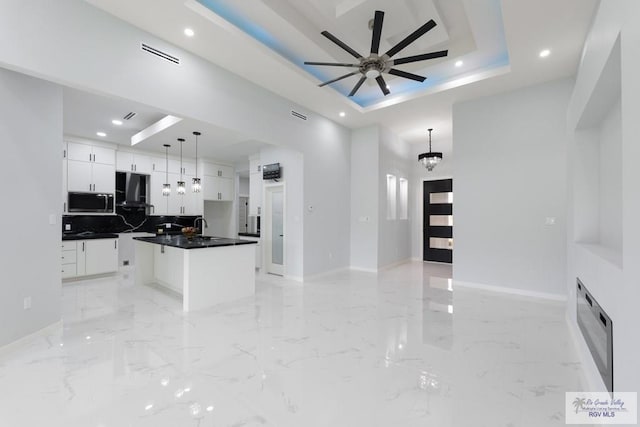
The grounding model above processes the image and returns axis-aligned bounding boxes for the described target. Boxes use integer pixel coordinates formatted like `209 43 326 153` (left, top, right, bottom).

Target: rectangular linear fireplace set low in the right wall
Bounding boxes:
576 278 613 393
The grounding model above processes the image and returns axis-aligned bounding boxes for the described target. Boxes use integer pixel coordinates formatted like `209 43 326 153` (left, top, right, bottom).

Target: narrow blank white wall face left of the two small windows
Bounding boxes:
351 126 384 271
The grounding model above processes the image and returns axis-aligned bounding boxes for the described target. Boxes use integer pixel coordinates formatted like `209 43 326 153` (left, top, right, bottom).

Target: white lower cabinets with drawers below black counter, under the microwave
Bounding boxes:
61 239 118 279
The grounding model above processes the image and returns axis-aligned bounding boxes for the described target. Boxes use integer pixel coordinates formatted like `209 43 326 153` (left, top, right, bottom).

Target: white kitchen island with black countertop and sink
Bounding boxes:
134 235 256 311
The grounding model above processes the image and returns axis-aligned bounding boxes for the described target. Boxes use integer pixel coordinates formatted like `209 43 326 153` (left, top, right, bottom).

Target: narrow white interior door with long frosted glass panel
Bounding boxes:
265 185 285 276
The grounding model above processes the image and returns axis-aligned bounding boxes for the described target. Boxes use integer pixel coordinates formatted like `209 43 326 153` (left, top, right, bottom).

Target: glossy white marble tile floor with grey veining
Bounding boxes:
0 262 584 427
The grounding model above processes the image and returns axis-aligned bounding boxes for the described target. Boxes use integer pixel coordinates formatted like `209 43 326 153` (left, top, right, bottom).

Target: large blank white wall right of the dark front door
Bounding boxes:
453 80 573 295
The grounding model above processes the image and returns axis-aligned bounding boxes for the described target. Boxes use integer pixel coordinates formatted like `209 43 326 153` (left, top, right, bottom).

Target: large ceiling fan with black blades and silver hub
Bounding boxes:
305 10 449 96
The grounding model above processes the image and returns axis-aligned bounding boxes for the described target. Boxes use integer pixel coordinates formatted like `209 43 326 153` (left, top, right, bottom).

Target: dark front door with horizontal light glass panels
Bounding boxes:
423 179 453 263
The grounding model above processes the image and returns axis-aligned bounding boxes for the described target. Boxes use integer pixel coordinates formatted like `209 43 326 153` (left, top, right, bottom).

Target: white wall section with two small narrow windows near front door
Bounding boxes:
378 126 412 267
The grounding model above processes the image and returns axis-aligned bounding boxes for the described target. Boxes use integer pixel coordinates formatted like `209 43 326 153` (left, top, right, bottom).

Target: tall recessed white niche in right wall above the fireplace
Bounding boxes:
573 37 622 267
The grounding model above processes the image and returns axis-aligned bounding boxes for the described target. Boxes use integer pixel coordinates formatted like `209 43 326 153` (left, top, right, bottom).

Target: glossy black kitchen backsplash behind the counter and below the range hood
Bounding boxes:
62 213 197 233
